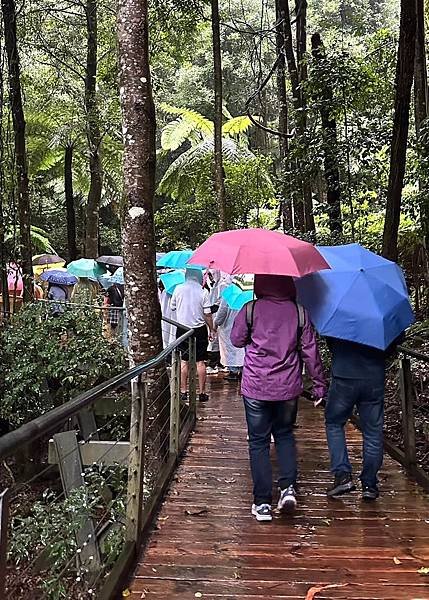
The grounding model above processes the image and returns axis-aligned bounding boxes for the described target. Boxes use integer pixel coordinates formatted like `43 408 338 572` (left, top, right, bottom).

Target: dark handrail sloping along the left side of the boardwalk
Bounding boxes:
0 319 194 460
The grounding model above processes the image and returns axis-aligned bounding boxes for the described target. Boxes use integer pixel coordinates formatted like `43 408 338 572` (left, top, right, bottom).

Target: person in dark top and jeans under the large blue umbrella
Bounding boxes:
325 338 400 501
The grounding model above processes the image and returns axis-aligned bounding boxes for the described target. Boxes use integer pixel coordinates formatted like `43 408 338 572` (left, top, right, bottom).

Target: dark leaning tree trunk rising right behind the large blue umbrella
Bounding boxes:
383 0 416 260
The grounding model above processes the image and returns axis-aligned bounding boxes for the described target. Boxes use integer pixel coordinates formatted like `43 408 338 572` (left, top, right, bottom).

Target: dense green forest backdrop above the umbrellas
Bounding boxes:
0 0 427 300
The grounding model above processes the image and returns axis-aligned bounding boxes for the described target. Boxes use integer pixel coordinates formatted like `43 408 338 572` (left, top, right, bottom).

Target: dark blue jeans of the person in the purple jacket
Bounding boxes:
243 397 298 505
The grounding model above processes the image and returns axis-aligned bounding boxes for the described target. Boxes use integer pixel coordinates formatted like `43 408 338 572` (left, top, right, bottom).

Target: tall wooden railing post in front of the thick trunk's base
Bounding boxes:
126 375 147 547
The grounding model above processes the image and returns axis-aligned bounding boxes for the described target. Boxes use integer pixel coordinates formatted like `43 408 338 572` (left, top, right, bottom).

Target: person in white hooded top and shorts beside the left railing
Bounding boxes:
170 267 214 402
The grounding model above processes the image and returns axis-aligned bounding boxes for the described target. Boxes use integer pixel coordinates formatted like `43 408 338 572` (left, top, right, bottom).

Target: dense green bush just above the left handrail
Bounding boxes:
0 303 125 427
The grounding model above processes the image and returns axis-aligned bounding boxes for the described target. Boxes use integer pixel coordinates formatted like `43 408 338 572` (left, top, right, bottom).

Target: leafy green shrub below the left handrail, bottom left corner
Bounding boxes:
8 465 126 600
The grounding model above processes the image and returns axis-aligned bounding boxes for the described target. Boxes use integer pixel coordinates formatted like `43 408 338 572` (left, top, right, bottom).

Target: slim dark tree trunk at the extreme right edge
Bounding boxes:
414 0 429 249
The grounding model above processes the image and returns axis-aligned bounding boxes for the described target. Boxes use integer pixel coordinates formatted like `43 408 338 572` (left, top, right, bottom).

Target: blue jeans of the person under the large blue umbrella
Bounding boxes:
325 377 384 487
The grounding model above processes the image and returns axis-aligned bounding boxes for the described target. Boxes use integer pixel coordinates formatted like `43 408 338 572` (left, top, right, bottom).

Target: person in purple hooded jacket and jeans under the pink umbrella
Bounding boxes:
231 275 326 521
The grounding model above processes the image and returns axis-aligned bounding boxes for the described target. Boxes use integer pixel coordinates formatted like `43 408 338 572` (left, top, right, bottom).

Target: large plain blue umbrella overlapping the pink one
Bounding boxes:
296 244 414 350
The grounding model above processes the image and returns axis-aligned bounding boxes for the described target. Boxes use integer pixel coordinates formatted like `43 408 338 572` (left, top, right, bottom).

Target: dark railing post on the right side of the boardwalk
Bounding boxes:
399 358 417 471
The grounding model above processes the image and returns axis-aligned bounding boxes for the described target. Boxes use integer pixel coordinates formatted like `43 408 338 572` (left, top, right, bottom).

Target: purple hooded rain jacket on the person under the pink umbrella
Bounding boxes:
231 275 326 401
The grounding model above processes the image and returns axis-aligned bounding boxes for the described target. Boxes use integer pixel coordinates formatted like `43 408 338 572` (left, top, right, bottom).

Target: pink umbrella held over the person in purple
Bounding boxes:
188 229 330 277
